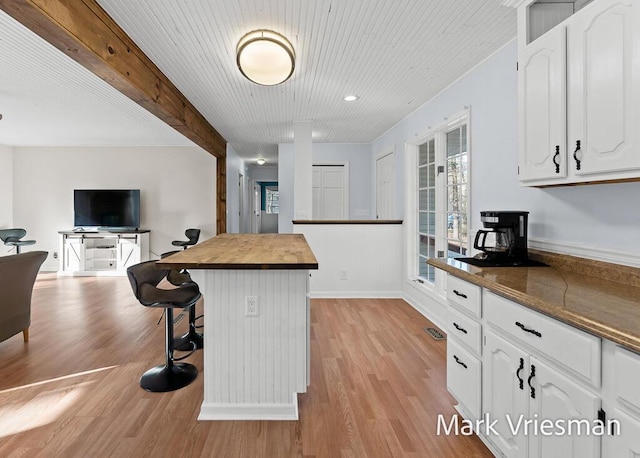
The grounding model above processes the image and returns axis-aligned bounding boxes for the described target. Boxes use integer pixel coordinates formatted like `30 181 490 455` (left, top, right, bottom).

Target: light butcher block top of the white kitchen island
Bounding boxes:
157 234 318 270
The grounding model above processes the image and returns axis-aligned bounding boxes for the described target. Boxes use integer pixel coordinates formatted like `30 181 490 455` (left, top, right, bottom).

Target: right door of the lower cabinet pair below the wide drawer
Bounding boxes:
527 356 601 458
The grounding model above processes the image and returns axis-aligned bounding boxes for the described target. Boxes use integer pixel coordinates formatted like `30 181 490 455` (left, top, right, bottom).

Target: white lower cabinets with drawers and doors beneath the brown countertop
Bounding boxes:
447 276 640 458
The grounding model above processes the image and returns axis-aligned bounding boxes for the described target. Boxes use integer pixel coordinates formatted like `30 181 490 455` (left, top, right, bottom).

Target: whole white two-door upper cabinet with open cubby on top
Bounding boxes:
518 0 640 186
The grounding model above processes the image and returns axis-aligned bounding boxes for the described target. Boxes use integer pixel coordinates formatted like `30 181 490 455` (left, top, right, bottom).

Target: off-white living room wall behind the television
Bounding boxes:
13 147 216 270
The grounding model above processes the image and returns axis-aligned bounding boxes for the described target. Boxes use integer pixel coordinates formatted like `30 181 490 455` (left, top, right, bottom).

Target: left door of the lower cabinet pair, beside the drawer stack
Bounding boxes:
482 331 529 458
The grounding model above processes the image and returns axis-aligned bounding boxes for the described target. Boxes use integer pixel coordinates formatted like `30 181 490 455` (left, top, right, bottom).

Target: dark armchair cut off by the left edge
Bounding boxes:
0 251 48 342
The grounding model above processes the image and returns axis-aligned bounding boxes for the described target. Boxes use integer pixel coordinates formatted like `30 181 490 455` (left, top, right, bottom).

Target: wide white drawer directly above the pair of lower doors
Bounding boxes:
482 290 601 387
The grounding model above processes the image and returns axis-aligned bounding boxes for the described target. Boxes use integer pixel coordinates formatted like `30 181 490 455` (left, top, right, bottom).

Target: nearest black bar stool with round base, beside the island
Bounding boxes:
127 261 200 393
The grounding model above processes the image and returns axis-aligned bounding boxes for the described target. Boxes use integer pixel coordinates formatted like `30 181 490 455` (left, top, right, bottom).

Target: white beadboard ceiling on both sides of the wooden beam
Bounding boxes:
0 0 516 162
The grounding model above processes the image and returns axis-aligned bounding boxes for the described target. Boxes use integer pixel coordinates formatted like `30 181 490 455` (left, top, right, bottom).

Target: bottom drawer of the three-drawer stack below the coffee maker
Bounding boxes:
447 339 482 418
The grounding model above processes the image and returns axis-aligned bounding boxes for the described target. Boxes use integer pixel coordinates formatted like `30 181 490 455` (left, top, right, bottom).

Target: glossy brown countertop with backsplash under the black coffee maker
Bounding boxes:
428 250 640 353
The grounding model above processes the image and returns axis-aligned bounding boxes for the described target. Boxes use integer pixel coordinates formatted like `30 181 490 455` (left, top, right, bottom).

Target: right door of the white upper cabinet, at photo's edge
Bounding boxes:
567 0 640 179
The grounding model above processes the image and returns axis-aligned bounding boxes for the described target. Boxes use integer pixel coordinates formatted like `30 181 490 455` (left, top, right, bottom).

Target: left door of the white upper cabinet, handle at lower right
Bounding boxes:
518 26 567 181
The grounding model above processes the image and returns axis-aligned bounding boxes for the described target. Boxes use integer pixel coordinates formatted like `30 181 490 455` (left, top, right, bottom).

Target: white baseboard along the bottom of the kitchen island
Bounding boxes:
198 393 298 421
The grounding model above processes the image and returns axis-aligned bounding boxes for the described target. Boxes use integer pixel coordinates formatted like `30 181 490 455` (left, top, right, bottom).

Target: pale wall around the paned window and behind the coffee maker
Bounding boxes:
371 42 640 323
